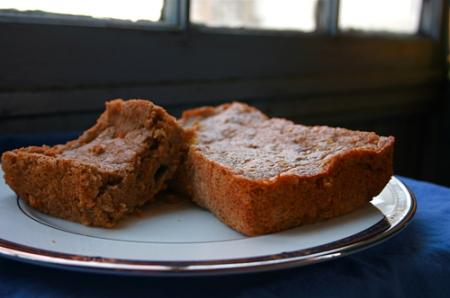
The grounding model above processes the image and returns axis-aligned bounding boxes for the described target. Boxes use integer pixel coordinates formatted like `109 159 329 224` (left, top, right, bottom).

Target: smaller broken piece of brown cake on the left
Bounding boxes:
2 99 184 227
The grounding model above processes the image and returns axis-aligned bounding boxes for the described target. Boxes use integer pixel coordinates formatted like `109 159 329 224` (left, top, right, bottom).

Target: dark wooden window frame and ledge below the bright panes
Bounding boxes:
0 0 448 120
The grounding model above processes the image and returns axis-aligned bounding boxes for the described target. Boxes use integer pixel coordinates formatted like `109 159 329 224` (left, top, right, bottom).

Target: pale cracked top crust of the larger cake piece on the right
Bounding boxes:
181 102 394 180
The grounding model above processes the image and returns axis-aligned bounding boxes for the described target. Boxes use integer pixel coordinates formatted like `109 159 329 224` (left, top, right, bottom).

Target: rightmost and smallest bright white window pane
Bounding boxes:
339 0 422 33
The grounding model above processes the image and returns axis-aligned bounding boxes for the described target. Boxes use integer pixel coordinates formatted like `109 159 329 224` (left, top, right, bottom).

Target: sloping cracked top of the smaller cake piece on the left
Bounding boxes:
22 99 176 171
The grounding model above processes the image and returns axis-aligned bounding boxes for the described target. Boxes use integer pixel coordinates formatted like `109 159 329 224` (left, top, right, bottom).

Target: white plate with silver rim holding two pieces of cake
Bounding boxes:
0 171 416 275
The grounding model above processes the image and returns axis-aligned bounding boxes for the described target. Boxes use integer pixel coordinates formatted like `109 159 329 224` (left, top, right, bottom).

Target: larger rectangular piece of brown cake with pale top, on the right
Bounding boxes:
175 103 394 236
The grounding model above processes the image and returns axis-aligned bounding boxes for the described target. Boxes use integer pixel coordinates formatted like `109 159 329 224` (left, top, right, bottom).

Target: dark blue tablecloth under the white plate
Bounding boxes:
0 178 450 298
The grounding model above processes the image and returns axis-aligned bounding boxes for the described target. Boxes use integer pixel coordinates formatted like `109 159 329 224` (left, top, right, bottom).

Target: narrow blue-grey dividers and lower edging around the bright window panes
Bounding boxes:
0 0 438 39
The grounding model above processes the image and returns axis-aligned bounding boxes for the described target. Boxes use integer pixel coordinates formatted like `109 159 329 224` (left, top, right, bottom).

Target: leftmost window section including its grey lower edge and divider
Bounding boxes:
0 0 178 27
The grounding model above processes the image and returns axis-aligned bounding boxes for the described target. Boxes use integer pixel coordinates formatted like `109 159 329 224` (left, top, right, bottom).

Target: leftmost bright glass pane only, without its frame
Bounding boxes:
0 0 164 21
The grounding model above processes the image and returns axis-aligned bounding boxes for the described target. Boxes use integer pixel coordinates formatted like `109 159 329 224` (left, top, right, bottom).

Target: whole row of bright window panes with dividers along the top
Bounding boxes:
0 0 428 34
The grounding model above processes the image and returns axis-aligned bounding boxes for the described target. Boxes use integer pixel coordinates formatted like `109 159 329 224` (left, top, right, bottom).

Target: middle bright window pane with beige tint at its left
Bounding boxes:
191 0 318 31
